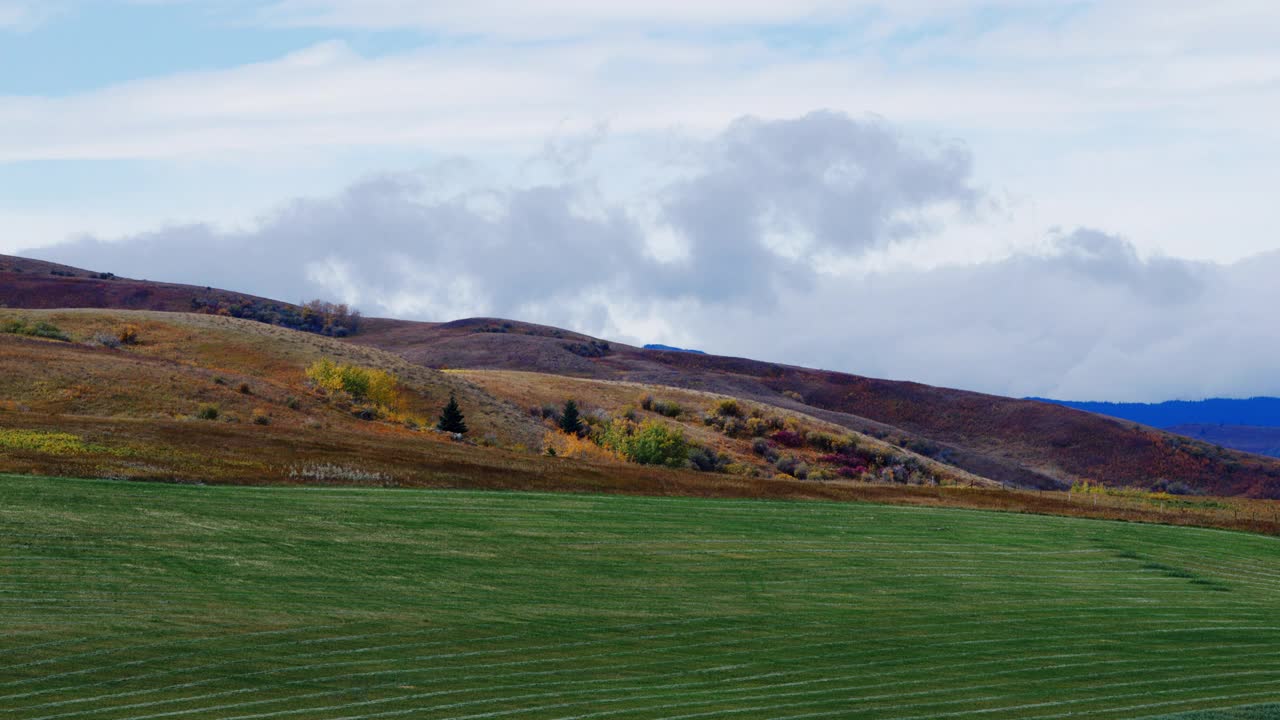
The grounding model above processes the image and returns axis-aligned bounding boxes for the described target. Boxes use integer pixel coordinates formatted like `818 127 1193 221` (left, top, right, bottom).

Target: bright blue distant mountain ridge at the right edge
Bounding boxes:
1028 397 1280 428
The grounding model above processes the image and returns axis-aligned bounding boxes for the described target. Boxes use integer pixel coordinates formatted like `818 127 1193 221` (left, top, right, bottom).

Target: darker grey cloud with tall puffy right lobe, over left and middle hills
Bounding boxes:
41 111 982 320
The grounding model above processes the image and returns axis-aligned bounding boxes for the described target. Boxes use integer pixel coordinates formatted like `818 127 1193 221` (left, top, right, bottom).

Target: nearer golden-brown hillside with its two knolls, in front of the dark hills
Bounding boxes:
0 309 1008 497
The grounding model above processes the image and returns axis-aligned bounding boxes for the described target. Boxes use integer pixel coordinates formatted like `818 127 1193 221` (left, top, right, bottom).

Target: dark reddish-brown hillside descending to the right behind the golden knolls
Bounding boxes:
355 318 1280 497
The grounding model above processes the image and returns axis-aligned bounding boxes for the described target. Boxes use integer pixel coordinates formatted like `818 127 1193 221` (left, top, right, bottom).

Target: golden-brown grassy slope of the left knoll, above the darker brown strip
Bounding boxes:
0 310 541 447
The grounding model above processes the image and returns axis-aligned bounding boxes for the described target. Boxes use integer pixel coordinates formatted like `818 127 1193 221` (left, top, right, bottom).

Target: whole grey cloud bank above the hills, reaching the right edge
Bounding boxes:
30 113 1280 400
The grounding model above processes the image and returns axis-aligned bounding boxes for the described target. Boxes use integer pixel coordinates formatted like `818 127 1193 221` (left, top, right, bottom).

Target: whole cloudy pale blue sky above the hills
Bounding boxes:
0 0 1280 401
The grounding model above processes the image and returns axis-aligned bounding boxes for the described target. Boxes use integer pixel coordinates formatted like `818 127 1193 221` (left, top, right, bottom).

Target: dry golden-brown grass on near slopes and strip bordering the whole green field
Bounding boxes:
0 304 1280 533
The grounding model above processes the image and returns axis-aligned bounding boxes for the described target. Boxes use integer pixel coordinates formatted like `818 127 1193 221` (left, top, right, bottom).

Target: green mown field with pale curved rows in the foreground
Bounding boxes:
0 477 1280 720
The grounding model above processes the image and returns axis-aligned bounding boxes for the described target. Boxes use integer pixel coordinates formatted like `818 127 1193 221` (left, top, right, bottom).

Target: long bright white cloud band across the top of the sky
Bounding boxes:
10 0 1280 163
